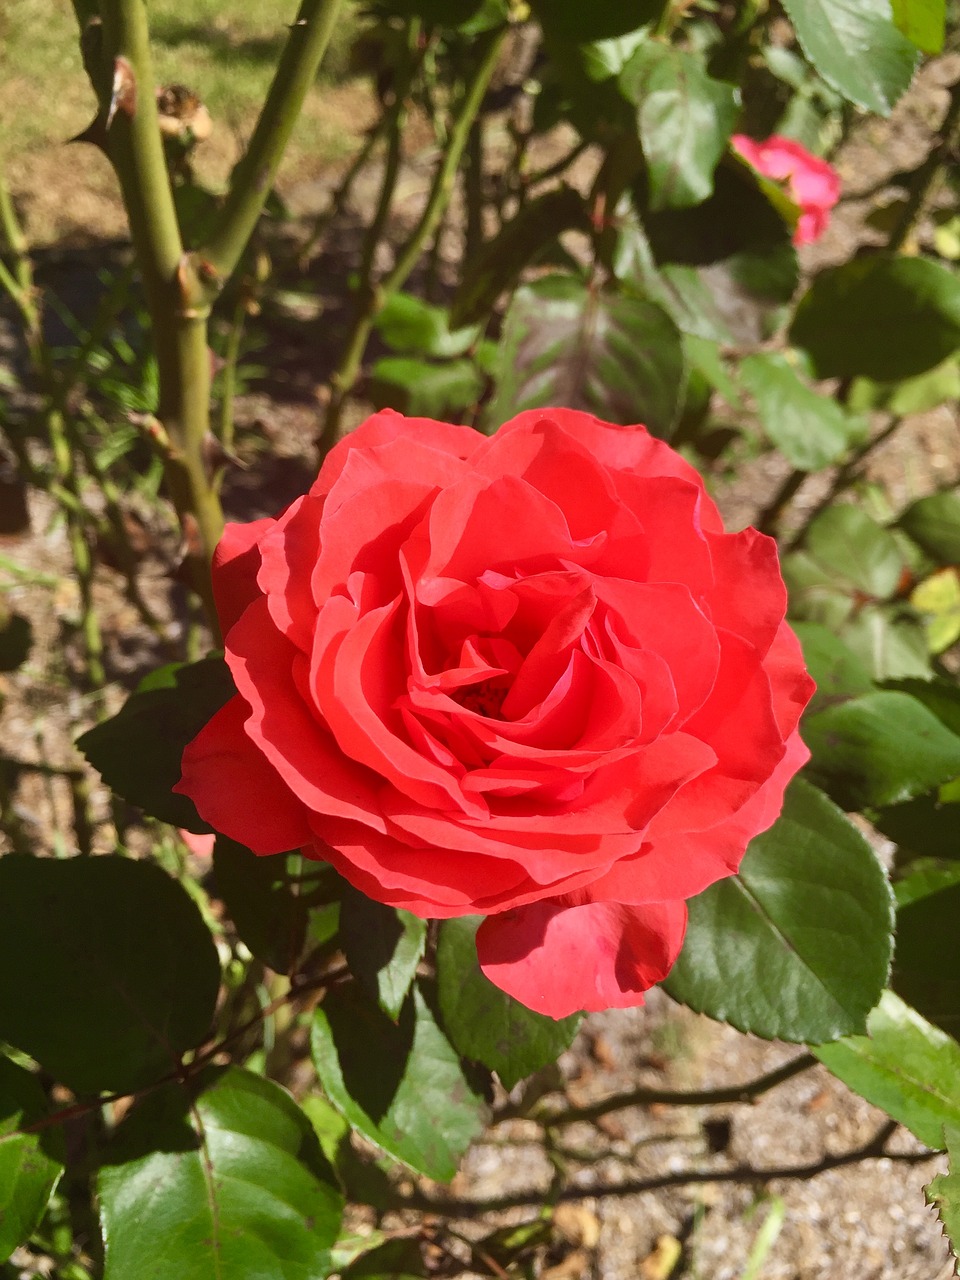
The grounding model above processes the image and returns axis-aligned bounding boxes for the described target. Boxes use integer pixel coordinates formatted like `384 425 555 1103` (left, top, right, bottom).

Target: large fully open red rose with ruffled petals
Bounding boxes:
177 408 813 1018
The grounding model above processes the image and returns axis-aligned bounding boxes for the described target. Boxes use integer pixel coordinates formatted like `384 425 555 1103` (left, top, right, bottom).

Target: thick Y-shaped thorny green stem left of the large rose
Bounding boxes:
92 0 342 640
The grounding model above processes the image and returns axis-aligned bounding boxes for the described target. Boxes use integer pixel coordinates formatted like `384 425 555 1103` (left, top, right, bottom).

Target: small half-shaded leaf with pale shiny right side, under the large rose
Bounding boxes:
340 887 426 1020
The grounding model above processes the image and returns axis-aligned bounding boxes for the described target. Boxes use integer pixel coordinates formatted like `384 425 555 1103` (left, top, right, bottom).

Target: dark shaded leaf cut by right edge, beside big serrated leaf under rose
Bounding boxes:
891 880 960 1039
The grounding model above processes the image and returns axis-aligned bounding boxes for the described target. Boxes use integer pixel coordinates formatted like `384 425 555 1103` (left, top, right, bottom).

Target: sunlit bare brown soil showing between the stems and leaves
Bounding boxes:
0 24 960 1280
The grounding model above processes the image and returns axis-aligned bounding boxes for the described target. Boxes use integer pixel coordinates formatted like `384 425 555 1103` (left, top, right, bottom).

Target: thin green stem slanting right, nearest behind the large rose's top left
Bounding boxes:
317 27 507 457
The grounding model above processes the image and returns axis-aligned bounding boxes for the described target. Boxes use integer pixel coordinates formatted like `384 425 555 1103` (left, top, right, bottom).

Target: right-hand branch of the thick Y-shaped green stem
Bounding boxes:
198 0 342 284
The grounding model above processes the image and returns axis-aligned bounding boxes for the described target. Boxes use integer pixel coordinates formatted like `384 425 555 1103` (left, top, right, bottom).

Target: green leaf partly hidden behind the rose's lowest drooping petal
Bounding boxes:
436 916 581 1089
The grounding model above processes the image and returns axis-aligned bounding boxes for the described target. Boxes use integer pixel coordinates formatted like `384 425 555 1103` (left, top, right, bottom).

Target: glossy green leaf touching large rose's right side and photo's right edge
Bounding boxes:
804 690 960 810
